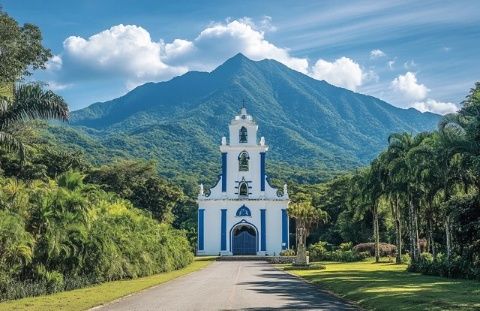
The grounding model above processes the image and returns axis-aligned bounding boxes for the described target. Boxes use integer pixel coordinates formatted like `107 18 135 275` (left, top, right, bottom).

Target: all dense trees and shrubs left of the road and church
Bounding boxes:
0 10 193 300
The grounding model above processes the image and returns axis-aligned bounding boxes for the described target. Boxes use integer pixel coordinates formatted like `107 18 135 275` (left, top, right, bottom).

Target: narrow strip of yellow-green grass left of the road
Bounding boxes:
0 257 216 311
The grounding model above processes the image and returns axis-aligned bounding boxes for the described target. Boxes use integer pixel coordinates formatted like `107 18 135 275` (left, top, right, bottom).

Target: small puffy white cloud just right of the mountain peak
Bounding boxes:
312 57 364 91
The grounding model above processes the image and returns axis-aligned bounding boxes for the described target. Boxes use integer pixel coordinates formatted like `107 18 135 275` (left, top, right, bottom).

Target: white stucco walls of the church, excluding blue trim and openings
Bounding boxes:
197 108 289 255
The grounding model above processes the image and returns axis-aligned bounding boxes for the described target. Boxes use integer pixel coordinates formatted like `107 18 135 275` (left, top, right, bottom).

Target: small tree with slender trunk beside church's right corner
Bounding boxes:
287 196 328 265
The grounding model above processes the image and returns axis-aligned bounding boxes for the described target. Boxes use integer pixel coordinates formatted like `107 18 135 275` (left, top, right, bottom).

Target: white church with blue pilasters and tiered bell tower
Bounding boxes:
197 108 289 256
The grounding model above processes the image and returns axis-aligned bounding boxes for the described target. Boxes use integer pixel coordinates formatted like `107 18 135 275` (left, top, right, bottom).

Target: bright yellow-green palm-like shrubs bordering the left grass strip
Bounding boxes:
0 172 193 300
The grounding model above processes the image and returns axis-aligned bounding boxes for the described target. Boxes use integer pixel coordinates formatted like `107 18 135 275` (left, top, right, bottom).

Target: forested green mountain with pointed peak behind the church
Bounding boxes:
47 54 439 185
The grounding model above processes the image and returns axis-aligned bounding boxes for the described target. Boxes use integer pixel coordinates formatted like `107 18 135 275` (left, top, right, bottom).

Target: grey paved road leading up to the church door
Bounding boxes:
96 261 355 311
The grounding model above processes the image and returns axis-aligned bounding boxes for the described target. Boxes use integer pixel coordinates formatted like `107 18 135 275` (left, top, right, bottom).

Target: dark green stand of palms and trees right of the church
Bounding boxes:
298 83 480 279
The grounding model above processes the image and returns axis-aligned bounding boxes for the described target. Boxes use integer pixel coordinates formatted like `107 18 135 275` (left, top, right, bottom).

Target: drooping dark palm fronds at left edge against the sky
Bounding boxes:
0 84 68 162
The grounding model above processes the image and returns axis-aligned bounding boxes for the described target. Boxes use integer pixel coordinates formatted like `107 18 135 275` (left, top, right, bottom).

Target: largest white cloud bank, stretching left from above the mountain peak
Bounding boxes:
57 16 308 89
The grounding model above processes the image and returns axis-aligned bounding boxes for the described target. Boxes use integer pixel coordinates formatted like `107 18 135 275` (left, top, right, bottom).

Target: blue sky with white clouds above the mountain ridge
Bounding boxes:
0 0 480 113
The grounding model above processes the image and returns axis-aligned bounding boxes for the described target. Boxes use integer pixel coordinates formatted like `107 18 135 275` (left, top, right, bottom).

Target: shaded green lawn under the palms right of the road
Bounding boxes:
289 260 480 310
